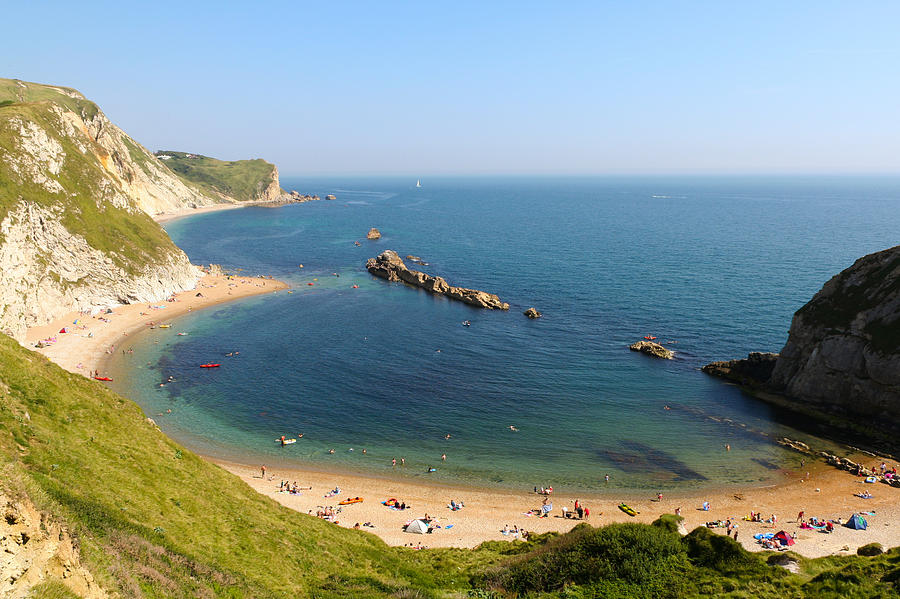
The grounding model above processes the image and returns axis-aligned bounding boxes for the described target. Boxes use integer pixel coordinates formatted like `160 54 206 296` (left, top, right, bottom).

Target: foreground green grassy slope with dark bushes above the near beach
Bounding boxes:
0 336 900 599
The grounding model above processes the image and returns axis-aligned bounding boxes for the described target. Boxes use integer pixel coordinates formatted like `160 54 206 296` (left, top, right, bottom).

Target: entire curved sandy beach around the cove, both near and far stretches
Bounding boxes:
26 253 900 557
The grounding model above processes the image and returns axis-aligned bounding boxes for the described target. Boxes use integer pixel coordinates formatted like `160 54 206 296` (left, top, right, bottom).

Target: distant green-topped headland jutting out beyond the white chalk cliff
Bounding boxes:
156 151 275 202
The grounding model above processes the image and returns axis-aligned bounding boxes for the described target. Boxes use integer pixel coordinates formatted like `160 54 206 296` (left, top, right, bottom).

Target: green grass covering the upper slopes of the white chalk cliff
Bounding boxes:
0 101 176 272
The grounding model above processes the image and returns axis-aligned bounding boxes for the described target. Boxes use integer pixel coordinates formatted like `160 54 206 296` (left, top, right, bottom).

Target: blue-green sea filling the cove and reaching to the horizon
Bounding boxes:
107 177 900 492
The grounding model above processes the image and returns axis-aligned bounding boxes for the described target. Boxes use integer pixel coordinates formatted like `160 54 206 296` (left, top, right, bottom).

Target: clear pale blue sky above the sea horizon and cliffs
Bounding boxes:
7 0 900 176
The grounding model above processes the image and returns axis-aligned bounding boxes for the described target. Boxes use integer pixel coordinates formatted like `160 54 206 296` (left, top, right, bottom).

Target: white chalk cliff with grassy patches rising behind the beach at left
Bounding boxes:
0 80 200 338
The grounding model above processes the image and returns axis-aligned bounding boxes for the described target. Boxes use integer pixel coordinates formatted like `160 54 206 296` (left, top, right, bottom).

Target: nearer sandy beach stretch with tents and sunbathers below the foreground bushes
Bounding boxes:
220 454 900 557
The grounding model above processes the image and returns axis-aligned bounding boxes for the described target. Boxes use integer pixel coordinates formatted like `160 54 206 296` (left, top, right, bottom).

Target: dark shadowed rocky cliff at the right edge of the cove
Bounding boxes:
769 246 900 429
